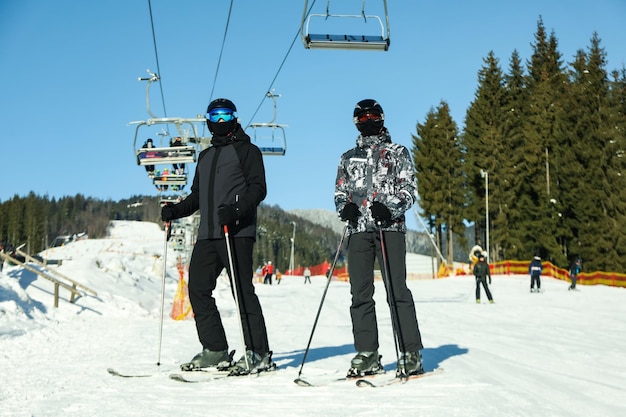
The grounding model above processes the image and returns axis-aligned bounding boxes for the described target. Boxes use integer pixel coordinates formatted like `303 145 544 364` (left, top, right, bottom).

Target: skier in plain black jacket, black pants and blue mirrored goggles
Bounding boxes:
161 98 274 374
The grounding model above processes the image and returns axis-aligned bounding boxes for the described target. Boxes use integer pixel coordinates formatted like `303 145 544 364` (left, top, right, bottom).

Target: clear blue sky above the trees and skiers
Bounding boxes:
0 0 626 230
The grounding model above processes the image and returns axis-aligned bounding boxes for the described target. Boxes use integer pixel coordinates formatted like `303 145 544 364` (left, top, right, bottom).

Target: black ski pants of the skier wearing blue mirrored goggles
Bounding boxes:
189 237 269 355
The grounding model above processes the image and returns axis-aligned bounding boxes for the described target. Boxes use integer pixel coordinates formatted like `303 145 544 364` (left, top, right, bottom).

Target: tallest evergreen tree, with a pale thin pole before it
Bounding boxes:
510 19 567 261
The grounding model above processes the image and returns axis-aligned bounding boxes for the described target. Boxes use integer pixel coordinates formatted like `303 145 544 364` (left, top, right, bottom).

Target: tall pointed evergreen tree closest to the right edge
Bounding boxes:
561 34 626 270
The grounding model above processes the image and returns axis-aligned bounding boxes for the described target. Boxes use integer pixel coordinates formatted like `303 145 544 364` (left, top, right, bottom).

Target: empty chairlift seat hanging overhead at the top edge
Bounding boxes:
300 0 390 51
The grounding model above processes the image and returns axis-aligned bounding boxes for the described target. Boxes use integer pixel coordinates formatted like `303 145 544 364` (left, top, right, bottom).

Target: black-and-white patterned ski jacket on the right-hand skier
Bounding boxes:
335 128 417 234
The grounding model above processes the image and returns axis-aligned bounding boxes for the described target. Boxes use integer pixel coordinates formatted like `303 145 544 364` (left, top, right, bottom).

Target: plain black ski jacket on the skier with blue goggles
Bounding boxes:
167 125 267 239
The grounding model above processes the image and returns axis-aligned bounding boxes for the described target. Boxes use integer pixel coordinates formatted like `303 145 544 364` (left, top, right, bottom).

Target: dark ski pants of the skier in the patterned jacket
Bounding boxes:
348 232 424 352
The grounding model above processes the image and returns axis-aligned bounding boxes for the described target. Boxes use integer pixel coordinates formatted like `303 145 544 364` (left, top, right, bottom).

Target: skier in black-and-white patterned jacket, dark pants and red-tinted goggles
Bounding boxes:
335 99 423 377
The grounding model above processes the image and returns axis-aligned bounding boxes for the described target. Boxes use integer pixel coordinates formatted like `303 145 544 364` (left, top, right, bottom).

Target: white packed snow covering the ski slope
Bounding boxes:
0 222 626 417
